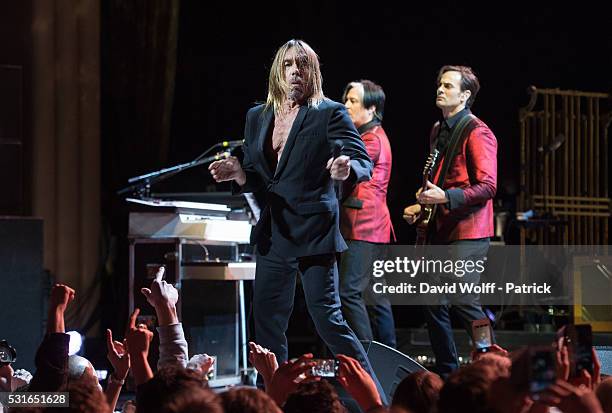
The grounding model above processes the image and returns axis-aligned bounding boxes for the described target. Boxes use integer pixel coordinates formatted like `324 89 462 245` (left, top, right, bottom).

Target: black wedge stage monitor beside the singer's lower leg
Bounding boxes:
361 341 427 403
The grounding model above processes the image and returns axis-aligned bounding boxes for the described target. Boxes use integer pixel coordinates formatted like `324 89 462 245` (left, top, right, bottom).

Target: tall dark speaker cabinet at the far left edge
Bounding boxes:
0 217 47 373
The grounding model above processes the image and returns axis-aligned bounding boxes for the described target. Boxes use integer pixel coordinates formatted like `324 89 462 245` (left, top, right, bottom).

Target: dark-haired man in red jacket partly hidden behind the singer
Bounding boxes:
340 80 396 348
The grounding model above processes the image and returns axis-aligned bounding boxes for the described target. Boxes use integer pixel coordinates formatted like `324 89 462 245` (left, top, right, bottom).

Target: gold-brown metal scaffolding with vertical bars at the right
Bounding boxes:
518 86 612 245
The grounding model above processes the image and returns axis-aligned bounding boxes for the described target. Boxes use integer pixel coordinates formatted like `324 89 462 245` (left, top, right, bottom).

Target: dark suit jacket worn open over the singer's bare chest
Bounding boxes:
241 99 372 257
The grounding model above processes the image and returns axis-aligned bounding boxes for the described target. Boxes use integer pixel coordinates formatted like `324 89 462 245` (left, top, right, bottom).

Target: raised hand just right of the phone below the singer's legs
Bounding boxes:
336 354 383 411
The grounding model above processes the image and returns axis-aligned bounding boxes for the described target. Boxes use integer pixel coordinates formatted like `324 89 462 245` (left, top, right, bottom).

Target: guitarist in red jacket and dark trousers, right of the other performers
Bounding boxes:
404 66 497 375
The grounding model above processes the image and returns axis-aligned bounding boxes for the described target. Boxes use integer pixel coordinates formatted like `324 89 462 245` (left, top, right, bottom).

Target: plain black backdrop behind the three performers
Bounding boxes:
169 1 612 243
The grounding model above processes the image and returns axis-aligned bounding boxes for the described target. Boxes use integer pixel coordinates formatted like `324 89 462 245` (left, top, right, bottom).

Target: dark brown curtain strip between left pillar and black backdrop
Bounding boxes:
101 0 180 331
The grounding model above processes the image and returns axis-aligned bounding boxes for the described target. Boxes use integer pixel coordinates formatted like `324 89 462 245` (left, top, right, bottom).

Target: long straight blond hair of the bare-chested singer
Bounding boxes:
266 39 325 113
